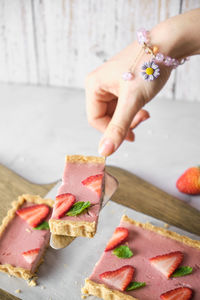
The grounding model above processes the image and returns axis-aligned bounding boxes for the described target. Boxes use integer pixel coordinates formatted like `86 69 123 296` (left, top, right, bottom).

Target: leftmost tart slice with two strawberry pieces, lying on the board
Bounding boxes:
0 195 53 280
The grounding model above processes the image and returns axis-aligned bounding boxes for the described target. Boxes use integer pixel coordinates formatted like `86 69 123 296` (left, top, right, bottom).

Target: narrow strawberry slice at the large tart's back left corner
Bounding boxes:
105 227 128 251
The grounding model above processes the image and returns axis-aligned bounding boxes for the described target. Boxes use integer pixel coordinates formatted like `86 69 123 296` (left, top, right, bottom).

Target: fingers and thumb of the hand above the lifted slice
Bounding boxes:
86 70 149 156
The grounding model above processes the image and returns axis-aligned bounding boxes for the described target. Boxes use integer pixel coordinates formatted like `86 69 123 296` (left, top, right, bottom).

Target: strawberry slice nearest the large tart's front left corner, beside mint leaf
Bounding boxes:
99 265 134 291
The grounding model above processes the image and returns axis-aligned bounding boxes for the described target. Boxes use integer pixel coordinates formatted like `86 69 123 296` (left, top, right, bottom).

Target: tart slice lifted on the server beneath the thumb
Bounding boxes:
49 155 105 238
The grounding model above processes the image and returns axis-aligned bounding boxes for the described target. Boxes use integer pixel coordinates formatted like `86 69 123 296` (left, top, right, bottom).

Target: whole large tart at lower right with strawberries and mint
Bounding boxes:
82 216 200 300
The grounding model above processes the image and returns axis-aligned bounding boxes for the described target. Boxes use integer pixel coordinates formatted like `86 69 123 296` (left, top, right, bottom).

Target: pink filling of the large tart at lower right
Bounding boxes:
89 222 200 300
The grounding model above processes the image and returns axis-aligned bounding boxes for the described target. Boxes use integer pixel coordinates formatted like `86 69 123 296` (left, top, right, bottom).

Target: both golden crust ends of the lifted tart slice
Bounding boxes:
49 155 105 238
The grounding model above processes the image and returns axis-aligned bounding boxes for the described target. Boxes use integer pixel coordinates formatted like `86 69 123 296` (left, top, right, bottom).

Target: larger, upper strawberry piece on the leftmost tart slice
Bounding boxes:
16 204 50 227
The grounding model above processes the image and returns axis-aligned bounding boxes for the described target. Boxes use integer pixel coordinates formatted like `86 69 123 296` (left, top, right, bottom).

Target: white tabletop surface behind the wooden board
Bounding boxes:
0 84 200 209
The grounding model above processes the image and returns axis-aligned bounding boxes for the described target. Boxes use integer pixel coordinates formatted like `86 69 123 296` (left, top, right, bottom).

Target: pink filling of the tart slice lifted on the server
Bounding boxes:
52 162 104 222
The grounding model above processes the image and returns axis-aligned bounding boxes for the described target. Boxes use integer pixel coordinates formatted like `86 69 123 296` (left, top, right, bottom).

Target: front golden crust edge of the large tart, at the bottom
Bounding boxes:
82 278 138 300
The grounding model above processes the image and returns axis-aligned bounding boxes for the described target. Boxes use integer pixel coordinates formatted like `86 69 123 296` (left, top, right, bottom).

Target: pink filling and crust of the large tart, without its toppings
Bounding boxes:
82 216 200 300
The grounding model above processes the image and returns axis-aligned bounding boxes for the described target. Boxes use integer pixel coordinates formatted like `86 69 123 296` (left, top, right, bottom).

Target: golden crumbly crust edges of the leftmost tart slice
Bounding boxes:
0 194 54 280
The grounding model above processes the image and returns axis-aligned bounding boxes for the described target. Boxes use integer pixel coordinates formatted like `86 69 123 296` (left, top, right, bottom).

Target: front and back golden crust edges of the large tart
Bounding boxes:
82 215 200 300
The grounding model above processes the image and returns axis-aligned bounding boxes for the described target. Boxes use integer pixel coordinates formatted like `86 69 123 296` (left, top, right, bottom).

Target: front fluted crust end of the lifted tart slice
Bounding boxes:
49 219 96 238
